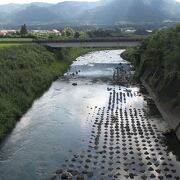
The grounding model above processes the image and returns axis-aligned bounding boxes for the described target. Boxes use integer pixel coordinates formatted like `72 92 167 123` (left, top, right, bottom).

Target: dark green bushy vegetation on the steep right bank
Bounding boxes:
122 25 180 107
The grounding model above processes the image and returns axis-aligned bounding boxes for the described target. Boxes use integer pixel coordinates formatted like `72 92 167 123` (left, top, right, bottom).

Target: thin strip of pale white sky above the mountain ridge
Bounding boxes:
0 0 180 4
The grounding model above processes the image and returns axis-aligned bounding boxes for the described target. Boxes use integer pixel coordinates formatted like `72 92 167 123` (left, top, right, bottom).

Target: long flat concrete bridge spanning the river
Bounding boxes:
33 38 143 48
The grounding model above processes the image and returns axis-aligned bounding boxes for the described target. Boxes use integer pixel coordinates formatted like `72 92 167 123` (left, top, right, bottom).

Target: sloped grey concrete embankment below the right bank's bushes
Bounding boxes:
140 77 180 140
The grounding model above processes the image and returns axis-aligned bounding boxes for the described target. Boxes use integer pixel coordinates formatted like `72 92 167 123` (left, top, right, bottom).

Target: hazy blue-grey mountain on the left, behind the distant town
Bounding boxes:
0 1 101 25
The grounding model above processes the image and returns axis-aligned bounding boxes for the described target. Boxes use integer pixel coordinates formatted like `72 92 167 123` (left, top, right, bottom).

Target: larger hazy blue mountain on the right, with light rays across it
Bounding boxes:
81 0 180 24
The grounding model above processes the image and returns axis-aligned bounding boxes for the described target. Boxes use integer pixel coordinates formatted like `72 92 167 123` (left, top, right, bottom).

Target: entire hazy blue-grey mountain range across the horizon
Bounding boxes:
0 0 180 25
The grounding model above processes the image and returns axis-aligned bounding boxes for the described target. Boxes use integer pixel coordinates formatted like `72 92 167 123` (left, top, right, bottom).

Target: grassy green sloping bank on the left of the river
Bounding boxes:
0 45 93 139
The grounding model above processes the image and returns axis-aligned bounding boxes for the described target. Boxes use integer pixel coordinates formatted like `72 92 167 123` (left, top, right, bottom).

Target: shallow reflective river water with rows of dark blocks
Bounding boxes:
0 50 180 180
